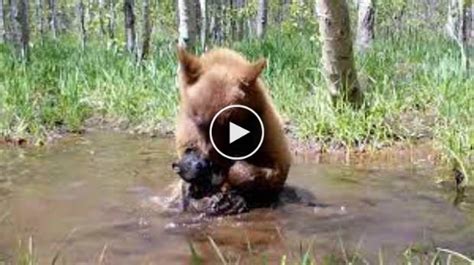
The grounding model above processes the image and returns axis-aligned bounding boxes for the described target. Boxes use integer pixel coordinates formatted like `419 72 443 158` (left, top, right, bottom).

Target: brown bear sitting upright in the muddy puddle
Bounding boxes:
176 47 291 214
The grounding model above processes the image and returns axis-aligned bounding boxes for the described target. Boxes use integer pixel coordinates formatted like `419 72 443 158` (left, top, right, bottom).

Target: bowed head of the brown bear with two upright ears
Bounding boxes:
178 47 266 133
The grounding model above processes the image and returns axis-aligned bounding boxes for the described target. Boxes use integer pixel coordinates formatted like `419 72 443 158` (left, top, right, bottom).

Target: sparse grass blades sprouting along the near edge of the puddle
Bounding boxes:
12 236 474 265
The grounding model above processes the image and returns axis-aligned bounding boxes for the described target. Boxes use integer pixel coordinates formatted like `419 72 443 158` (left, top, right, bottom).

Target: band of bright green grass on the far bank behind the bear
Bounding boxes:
0 33 474 183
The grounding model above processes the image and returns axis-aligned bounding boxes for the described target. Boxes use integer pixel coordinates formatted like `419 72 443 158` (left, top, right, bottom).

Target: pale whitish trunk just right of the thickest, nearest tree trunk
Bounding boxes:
357 0 375 52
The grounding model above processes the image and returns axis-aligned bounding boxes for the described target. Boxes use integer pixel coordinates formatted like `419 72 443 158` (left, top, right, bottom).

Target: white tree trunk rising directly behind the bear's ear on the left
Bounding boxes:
178 0 197 47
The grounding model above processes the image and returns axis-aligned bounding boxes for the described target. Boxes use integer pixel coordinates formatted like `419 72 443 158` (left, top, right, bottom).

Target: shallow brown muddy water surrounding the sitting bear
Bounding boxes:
0 133 474 264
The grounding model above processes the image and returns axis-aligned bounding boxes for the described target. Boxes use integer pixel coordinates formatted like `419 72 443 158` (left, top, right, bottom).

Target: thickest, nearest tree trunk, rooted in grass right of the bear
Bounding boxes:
318 0 363 107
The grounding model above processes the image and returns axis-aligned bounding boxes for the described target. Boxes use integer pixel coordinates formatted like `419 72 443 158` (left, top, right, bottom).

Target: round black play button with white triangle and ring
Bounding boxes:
209 105 264 160
